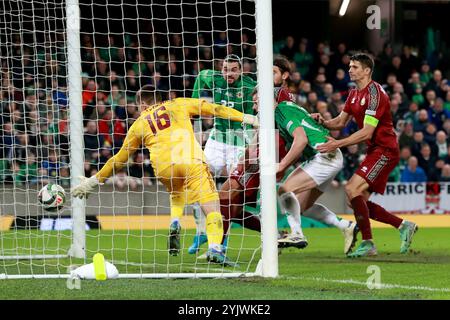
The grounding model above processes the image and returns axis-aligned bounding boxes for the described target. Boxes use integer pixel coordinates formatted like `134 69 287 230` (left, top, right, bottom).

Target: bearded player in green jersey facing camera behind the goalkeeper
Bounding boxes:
188 54 256 254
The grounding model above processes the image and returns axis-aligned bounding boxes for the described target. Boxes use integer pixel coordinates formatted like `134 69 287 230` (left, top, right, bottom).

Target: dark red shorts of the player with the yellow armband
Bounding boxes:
355 147 400 194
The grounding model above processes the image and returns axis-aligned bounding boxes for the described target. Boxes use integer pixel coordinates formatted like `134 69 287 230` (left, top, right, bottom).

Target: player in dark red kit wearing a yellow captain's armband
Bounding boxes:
314 53 418 257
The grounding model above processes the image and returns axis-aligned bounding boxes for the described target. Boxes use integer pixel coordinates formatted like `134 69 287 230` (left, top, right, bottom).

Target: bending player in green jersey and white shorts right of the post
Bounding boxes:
253 85 359 254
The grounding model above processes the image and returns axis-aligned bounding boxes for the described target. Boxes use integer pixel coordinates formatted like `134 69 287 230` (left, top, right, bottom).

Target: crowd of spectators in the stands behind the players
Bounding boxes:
0 32 450 190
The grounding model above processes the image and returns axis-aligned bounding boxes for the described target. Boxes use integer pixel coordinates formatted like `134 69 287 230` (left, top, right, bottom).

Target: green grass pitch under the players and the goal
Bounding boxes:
0 228 450 300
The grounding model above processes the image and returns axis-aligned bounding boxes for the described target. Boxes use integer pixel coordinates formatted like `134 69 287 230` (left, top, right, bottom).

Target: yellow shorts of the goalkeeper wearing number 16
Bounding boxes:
155 163 219 205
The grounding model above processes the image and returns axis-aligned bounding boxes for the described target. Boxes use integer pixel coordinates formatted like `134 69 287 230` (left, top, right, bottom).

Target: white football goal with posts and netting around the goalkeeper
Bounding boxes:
0 0 278 279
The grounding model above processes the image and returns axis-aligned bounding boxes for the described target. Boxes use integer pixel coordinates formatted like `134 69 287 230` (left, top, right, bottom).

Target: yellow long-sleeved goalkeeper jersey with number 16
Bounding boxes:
96 98 248 182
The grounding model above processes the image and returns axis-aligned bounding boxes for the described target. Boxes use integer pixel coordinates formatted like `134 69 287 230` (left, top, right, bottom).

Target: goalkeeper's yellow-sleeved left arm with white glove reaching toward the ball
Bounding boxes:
72 120 142 199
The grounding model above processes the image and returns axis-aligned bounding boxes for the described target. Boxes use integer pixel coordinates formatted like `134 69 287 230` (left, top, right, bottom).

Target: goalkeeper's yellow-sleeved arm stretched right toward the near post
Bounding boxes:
176 98 259 127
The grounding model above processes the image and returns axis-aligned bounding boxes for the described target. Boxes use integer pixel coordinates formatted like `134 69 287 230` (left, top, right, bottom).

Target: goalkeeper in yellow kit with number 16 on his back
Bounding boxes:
72 86 258 266
